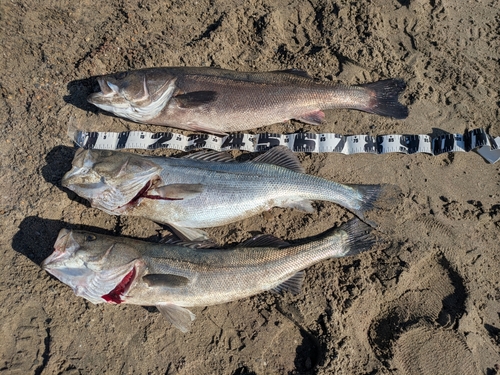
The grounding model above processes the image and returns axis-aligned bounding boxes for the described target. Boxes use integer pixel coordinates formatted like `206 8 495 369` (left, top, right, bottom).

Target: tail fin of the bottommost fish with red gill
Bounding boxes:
335 218 378 258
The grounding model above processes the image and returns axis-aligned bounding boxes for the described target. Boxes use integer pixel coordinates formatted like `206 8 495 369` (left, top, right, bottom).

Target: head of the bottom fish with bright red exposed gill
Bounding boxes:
42 229 145 303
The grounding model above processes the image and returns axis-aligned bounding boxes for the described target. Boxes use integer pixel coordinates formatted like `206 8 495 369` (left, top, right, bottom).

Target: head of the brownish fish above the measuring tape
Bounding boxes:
87 69 176 122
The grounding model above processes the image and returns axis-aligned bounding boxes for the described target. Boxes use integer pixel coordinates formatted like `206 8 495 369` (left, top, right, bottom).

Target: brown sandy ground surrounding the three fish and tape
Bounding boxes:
0 0 500 375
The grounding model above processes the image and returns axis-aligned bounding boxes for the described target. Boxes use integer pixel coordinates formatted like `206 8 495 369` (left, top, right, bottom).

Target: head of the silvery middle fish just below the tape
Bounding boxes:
61 149 161 215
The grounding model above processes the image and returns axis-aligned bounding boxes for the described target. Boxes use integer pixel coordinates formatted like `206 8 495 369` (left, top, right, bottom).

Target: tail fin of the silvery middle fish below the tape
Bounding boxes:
347 184 401 228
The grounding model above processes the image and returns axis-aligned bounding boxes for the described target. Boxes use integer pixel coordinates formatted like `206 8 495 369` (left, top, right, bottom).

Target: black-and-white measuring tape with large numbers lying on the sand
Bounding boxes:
73 128 500 163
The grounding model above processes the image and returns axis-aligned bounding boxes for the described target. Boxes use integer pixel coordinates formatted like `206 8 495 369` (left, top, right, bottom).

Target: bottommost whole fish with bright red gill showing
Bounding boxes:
42 219 376 332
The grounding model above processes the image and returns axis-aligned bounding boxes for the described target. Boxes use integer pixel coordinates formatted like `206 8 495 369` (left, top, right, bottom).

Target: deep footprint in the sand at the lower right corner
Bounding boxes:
368 256 479 375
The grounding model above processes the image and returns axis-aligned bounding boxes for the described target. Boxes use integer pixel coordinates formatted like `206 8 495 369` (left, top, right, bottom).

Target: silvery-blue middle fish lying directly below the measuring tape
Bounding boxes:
62 147 398 241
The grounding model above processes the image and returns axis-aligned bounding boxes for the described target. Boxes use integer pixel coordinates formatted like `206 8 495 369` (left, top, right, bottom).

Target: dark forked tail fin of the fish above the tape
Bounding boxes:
359 78 408 119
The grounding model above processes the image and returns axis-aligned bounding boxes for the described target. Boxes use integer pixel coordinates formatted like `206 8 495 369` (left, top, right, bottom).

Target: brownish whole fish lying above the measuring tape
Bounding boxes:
88 67 408 134
